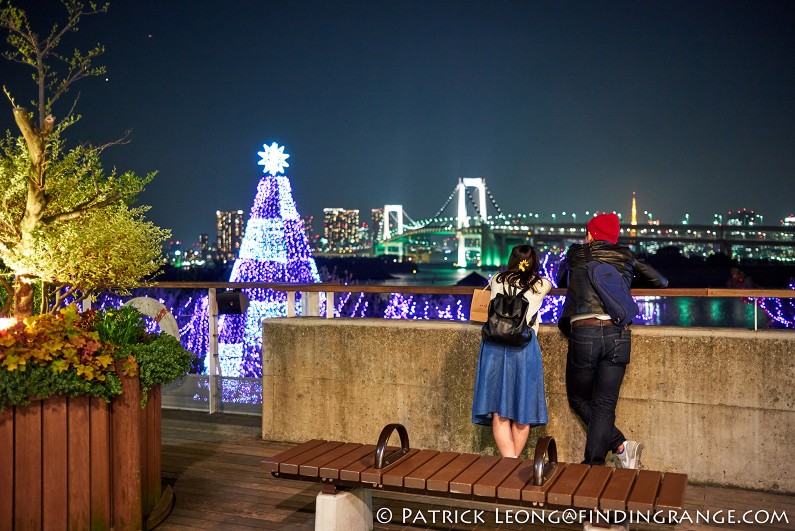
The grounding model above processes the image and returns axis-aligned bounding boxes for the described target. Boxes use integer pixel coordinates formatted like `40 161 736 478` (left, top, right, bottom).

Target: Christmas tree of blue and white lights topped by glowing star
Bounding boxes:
218 142 320 377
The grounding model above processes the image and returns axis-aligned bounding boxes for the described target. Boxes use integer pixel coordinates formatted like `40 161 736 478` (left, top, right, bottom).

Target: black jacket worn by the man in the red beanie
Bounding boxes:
557 240 668 335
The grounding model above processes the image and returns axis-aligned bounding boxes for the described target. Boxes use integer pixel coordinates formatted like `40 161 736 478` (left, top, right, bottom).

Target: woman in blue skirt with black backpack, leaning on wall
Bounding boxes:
472 245 552 457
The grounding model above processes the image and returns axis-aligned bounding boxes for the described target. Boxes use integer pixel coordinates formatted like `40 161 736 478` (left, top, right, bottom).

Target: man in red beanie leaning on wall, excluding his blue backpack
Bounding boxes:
557 214 668 468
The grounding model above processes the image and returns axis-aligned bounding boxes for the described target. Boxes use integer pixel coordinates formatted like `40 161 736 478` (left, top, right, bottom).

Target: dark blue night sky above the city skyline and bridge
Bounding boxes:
0 0 795 243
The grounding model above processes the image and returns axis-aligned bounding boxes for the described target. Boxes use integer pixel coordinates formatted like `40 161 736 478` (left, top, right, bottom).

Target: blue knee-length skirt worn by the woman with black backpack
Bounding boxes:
472 331 547 426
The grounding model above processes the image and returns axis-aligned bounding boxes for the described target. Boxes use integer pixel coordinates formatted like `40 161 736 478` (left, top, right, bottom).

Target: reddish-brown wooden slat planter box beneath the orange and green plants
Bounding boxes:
0 378 161 531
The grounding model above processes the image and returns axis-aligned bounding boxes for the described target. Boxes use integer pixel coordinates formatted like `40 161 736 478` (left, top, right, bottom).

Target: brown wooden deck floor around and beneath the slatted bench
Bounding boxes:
157 410 795 531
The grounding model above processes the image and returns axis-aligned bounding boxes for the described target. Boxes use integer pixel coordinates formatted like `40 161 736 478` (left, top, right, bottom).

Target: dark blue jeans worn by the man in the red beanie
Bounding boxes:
566 322 631 465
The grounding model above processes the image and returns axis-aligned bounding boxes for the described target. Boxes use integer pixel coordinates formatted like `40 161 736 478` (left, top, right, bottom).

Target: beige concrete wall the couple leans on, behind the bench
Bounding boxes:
262 318 795 493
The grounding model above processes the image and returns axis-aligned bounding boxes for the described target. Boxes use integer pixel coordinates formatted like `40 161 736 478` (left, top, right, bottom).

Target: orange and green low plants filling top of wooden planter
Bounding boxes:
0 306 193 409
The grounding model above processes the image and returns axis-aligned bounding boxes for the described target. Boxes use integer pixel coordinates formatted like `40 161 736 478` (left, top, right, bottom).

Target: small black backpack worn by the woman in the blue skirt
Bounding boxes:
481 285 538 347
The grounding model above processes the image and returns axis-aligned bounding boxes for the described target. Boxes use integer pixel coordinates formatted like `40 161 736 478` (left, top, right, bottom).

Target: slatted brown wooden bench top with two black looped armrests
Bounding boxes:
262 424 687 528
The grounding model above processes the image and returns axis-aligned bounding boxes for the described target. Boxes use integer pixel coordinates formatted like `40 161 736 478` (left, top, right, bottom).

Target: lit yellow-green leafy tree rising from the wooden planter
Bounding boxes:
0 0 169 317
